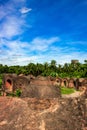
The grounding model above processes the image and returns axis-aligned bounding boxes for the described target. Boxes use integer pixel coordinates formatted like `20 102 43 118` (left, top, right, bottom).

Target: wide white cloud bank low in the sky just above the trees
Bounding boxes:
0 37 87 65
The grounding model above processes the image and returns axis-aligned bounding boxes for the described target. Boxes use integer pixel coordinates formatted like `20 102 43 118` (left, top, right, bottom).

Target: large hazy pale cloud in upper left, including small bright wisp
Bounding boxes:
0 0 31 39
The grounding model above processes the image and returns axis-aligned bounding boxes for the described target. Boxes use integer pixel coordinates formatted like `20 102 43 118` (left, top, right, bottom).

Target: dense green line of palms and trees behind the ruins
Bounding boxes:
0 60 87 78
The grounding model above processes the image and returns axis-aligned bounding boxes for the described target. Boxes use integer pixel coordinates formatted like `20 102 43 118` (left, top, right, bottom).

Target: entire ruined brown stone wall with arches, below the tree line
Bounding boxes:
2 74 87 98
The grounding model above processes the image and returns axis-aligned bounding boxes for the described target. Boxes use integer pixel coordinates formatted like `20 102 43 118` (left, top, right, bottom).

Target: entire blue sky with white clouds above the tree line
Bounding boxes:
0 0 87 65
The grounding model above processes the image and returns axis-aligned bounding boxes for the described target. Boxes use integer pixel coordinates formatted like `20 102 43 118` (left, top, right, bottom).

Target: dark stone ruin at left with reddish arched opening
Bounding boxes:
2 74 30 93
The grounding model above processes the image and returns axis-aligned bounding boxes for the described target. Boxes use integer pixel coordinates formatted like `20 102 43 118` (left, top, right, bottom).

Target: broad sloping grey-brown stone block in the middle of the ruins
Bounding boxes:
21 77 61 98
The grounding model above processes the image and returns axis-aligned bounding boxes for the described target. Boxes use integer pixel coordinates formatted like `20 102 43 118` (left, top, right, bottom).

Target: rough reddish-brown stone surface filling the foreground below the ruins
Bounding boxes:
0 97 87 130
